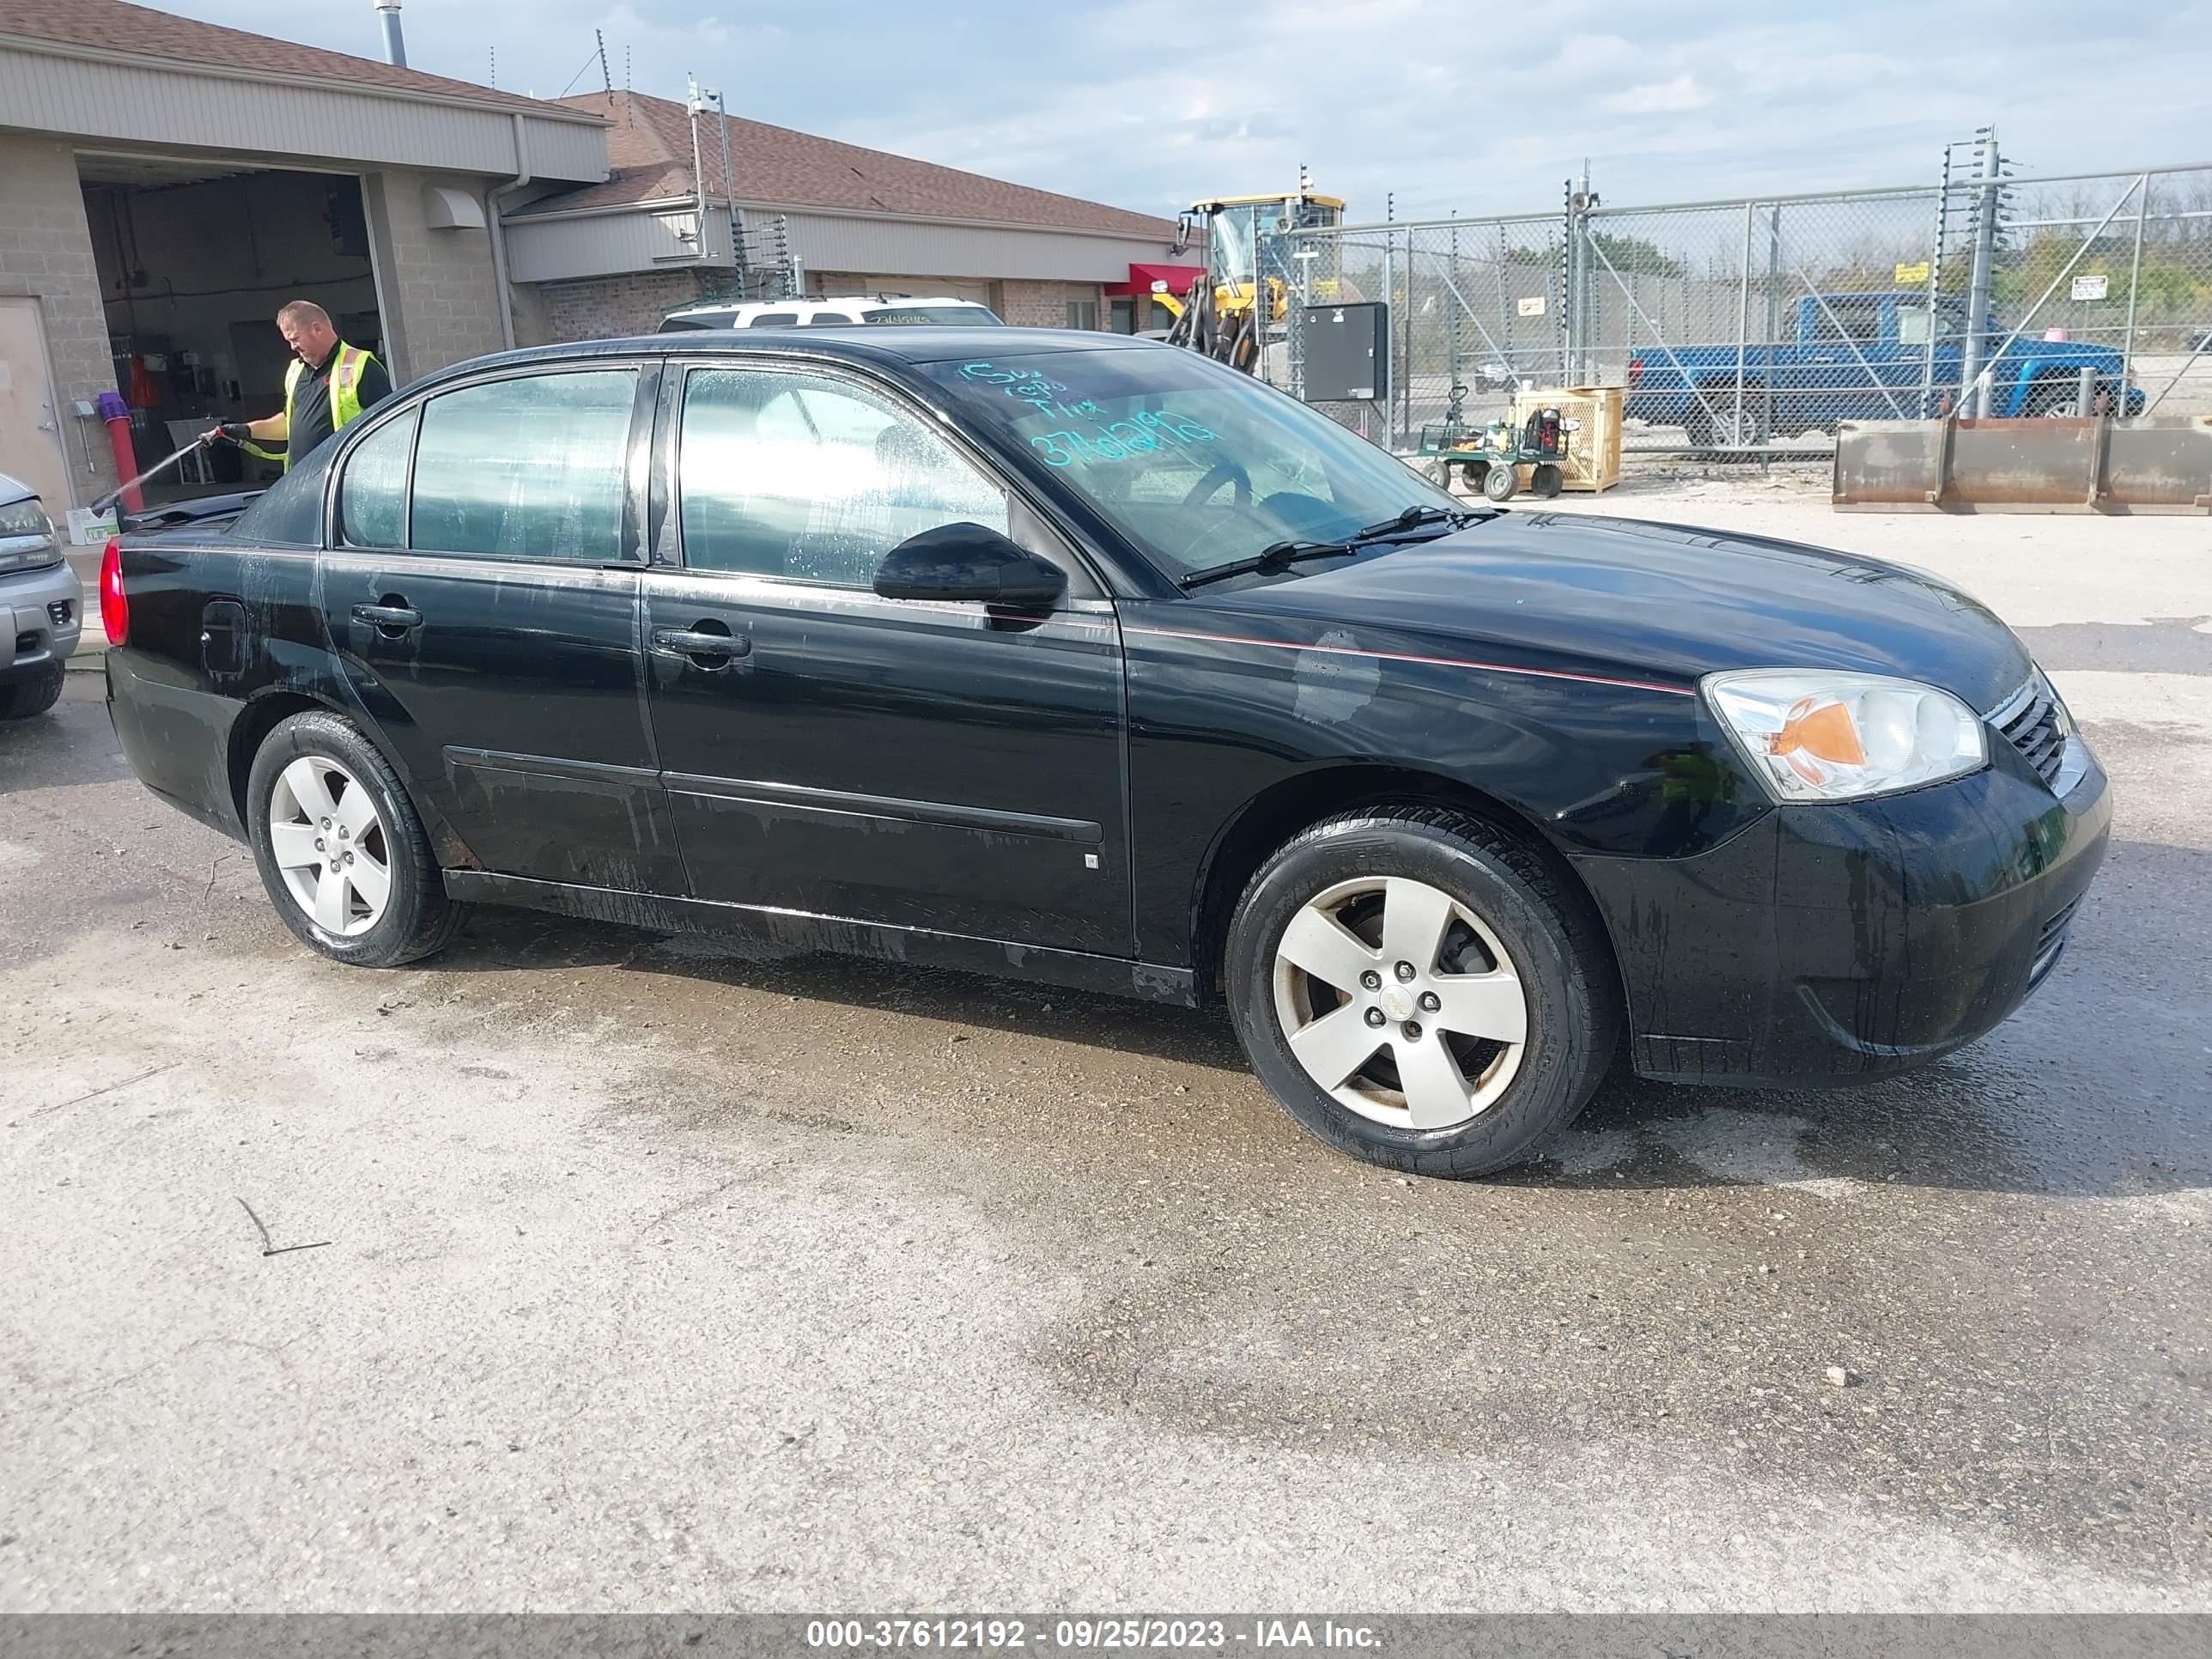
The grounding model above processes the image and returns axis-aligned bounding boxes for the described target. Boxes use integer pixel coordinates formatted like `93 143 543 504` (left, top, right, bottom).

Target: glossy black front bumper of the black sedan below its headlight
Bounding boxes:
1575 737 2112 1088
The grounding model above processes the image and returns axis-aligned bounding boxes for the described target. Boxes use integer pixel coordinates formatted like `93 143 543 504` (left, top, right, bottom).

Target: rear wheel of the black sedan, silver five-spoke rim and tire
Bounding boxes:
246 710 462 967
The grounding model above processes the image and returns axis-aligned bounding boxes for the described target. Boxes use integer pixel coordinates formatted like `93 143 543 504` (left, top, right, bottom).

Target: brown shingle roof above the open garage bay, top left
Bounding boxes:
0 0 591 119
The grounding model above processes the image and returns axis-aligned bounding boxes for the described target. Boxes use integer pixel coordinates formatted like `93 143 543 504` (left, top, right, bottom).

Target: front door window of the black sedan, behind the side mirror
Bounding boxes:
677 369 1006 588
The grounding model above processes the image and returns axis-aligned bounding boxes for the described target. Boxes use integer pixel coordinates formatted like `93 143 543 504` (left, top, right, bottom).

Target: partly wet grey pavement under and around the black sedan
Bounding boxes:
0 498 2212 1610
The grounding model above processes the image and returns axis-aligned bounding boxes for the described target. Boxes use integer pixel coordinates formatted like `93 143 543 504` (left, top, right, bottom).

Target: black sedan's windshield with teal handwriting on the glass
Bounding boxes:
921 347 1460 580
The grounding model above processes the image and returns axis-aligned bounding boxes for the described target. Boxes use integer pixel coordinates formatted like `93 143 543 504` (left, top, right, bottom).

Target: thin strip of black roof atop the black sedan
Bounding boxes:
407 323 1182 392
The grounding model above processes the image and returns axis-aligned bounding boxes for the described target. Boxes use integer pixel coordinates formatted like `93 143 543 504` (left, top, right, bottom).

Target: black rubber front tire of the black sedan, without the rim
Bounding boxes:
1224 805 1621 1179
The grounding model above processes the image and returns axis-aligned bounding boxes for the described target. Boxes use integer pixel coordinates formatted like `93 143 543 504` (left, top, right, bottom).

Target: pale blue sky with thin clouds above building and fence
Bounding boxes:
164 0 2212 222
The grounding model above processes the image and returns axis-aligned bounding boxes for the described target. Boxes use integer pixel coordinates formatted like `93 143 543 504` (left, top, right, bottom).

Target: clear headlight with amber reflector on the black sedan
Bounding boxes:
1704 668 1989 801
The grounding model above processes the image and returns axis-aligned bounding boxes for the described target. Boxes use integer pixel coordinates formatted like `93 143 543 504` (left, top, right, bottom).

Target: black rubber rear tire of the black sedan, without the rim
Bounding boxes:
246 710 467 967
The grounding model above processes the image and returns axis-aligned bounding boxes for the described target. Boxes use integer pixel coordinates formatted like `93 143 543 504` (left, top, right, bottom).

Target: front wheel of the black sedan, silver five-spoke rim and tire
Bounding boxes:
1225 805 1620 1179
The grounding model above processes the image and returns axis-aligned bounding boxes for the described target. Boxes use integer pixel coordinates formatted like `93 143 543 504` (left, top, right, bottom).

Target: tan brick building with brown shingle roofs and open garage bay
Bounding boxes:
0 0 1175 520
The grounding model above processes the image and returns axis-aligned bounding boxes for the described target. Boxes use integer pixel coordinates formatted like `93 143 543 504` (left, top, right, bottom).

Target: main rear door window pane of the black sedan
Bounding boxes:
410 369 637 564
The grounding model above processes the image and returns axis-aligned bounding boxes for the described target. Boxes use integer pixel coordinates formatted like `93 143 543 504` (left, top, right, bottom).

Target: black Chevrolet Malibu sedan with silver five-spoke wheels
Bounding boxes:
101 327 2111 1176
